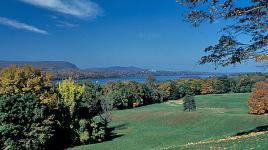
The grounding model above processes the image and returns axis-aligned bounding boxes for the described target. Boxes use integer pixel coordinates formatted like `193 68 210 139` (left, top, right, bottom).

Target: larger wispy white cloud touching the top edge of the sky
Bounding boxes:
21 0 101 18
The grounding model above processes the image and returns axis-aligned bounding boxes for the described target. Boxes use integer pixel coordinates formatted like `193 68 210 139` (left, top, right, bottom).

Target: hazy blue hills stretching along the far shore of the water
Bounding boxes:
0 60 219 80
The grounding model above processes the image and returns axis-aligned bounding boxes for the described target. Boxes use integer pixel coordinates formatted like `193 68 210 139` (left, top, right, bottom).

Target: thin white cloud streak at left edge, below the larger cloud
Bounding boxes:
0 17 48 34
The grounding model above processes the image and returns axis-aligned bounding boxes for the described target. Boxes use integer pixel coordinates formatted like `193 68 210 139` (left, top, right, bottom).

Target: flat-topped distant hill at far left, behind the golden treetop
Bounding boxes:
0 60 79 71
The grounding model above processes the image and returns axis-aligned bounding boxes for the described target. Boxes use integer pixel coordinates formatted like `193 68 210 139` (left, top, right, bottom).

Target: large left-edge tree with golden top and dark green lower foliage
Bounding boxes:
0 65 57 150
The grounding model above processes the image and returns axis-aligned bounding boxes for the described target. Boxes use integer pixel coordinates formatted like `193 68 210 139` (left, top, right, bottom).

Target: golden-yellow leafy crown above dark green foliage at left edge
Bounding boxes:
0 65 56 103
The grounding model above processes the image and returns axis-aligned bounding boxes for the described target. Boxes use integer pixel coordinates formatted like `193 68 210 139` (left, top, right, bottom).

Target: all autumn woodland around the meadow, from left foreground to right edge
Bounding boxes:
0 65 268 149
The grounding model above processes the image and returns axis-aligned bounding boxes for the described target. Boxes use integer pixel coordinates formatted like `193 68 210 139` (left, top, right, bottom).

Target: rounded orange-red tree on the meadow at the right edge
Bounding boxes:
248 80 268 115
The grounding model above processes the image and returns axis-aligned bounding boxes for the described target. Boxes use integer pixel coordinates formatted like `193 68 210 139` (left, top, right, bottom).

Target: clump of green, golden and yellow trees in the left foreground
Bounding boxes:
0 65 110 150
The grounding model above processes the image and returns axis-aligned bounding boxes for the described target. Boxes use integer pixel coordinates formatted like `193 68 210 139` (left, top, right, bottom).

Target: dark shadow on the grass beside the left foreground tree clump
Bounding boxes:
105 124 127 141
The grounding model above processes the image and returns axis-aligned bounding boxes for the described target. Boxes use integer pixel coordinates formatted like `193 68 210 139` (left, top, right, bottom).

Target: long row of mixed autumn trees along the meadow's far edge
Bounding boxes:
78 73 268 109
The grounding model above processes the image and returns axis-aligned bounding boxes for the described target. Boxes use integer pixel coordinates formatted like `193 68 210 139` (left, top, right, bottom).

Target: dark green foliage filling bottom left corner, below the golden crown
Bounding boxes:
0 93 56 150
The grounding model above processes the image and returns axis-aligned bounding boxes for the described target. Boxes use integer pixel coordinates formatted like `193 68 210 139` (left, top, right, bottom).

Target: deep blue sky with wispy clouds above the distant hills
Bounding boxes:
0 0 264 72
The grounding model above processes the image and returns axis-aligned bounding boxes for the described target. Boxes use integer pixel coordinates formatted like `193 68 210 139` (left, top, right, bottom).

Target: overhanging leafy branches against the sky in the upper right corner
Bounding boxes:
177 0 268 66
